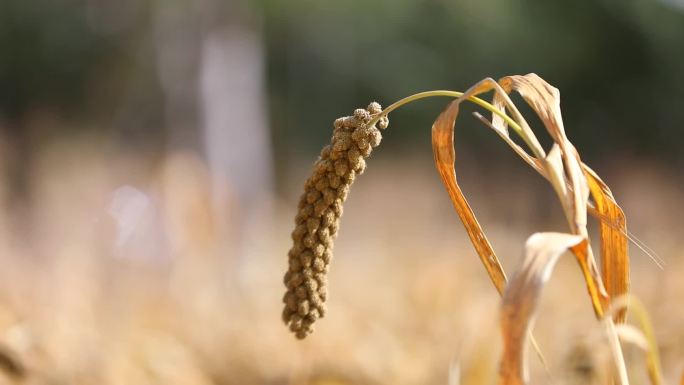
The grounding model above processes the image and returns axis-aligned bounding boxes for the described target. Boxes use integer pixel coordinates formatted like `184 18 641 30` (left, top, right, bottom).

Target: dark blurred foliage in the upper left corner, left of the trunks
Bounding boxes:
0 0 159 204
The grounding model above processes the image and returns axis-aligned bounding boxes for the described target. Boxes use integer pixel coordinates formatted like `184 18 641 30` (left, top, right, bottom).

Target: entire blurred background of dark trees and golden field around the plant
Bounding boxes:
0 0 684 384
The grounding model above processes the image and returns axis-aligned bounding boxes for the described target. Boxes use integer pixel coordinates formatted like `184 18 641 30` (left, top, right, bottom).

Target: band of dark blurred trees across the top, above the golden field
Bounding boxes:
0 0 684 192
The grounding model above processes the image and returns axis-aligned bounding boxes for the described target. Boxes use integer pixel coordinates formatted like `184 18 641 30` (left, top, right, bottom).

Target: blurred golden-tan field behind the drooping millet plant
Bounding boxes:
0 140 684 385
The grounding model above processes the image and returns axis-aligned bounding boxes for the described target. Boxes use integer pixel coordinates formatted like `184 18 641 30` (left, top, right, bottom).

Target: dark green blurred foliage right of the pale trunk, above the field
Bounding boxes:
261 0 684 174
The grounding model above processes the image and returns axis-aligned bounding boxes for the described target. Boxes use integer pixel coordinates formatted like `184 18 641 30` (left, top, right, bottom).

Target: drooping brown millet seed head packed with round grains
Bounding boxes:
283 102 389 338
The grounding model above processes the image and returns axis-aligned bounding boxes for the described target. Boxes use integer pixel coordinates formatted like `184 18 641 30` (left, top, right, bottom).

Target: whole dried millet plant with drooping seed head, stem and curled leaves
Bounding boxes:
283 74 662 385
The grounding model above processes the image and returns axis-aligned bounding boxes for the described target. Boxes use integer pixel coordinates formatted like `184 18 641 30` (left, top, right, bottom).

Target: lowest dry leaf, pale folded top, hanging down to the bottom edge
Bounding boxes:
499 233 587 385
